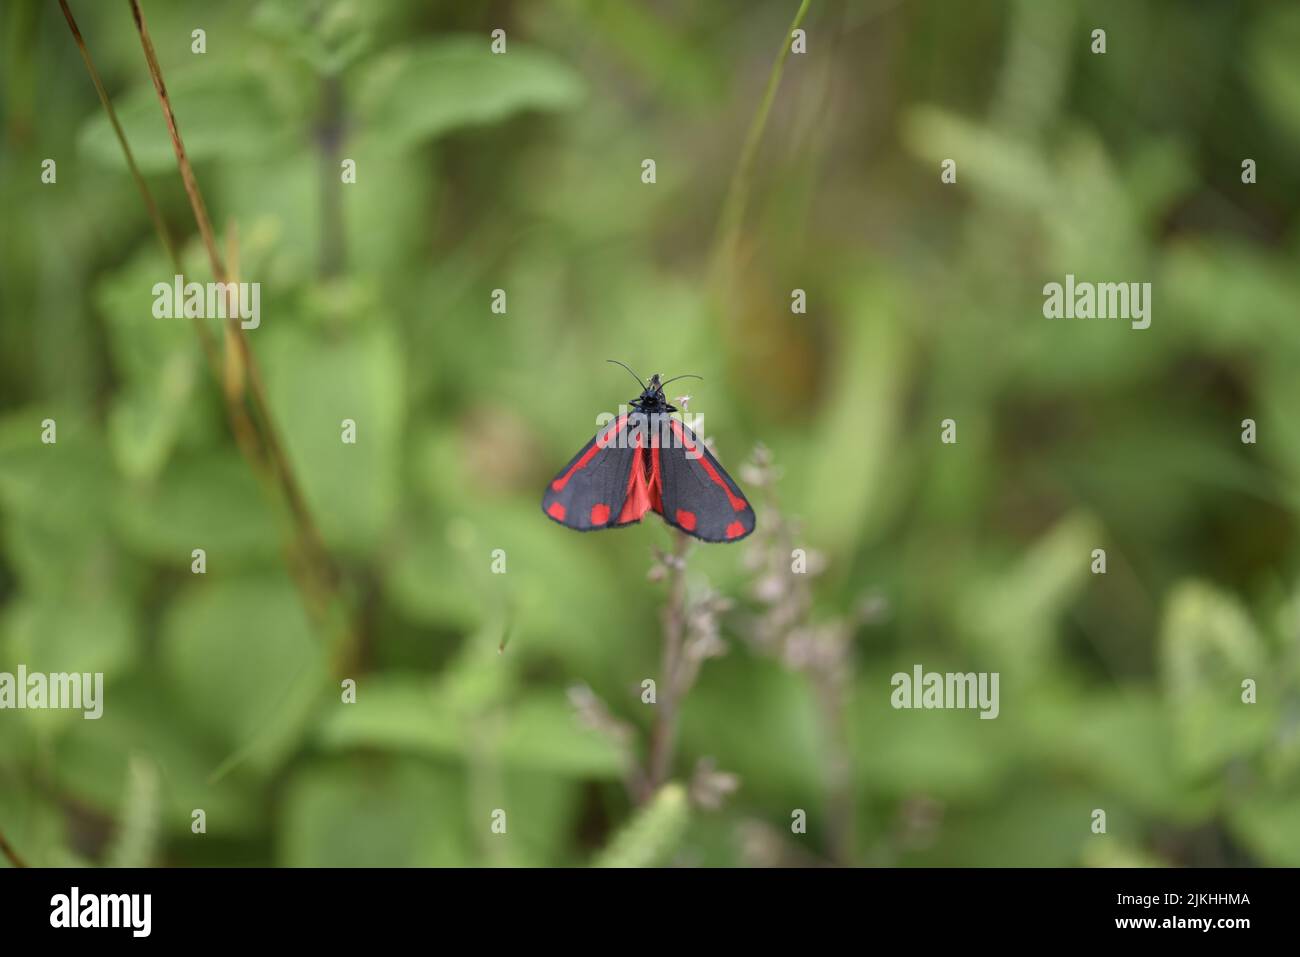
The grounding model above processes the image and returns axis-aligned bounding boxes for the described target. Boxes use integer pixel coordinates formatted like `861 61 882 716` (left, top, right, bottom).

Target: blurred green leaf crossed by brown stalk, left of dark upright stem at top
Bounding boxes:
77 66 296 173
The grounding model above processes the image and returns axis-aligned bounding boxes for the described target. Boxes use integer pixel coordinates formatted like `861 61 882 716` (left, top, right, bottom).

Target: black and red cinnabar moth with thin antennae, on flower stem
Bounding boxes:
542 359 754 542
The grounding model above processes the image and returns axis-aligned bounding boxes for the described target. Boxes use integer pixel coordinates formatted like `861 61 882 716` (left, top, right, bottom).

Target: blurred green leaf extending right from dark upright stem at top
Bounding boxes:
356 36 584 150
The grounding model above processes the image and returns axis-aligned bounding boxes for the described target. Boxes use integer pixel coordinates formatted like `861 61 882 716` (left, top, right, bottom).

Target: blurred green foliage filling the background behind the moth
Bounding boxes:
0 0 1300 866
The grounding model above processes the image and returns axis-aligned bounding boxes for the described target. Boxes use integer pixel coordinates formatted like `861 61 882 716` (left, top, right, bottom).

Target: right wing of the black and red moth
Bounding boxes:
650 416 754 542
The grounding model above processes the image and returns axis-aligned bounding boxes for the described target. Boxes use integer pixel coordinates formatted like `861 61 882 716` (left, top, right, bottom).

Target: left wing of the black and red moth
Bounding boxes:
542 412 650 532
